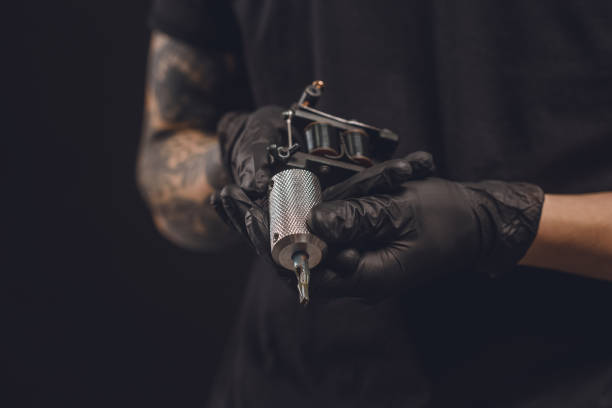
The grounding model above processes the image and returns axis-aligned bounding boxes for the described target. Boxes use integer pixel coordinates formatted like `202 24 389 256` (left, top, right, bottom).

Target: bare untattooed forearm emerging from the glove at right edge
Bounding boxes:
519 192 612 281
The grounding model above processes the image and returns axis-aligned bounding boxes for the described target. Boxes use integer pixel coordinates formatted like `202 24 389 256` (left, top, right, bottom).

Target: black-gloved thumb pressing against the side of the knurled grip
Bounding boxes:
307 195 416 246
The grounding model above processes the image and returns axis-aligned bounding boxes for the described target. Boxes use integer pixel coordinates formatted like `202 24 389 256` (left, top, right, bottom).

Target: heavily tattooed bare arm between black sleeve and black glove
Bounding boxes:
137 32 250 250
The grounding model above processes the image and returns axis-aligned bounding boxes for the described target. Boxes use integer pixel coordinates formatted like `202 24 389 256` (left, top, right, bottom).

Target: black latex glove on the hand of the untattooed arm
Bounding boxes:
309 170 544 297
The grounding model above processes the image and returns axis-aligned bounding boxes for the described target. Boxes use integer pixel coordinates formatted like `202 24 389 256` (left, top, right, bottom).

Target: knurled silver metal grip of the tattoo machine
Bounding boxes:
269 169 327 271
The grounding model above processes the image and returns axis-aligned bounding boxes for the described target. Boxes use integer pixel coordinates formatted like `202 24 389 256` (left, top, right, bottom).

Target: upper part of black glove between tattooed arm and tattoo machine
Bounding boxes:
217 106 290 198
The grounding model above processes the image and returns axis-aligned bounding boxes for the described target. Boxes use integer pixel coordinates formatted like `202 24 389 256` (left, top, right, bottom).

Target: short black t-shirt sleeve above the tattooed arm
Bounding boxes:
149 0 240 51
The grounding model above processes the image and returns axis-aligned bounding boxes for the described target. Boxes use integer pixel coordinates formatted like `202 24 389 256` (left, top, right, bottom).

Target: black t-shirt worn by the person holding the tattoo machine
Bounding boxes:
151 0 612 408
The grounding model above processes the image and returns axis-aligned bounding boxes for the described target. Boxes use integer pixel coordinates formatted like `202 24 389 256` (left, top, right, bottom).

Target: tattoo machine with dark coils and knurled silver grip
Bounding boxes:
268 81 398 304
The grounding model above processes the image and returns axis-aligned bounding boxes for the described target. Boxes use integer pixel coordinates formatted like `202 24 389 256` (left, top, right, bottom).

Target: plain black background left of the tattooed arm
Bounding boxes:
7 0 251 407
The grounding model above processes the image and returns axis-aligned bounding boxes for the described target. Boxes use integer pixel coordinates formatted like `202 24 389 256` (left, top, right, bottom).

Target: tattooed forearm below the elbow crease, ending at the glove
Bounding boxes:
138 130 235 250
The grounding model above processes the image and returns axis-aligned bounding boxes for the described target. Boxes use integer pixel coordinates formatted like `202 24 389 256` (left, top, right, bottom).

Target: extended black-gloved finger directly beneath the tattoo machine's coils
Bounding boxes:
323 152 435 201
